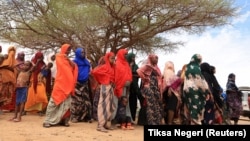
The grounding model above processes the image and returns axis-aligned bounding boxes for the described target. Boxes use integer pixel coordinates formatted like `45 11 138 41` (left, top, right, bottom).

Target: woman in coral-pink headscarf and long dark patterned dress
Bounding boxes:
137 54 163 125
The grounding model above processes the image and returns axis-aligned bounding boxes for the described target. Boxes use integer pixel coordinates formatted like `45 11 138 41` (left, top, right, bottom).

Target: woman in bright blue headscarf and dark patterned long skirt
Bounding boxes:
71 47 92 123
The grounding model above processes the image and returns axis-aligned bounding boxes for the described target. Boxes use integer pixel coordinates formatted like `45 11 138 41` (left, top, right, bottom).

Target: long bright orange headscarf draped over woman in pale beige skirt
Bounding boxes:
51 44 78 105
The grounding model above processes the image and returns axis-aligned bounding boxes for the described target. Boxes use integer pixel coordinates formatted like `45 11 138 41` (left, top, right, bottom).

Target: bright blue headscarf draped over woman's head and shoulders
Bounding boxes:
74 47 90 83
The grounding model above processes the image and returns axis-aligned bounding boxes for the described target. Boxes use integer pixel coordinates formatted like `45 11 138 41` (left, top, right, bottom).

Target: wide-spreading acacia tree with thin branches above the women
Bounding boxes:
0 0 237 64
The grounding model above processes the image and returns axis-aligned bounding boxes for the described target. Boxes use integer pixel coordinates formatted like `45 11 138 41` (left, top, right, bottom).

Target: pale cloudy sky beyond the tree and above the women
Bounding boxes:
1 0 250 88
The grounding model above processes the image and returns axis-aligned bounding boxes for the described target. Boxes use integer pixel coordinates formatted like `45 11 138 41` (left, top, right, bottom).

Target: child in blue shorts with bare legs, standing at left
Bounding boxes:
11 61 32 122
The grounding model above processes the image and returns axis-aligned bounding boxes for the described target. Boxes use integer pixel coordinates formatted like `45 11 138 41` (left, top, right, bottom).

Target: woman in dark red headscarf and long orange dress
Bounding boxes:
24 51 48 115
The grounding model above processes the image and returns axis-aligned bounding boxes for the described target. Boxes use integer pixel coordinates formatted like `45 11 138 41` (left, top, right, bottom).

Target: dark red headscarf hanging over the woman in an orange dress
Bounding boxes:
31 51 45 93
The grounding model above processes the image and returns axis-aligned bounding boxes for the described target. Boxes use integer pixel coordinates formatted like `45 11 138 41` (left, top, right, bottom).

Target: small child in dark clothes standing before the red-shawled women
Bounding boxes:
115 96 134 130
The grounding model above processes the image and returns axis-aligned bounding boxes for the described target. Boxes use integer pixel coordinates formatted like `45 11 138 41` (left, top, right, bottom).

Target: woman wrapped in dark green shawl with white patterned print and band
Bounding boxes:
183 54 211 125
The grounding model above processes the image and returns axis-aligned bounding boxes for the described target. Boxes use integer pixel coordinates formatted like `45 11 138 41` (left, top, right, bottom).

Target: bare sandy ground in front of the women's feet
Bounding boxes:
0 112 143 141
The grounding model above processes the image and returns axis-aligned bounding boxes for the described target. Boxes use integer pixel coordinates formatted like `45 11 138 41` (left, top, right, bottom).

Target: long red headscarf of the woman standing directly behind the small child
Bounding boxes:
115 49 132 98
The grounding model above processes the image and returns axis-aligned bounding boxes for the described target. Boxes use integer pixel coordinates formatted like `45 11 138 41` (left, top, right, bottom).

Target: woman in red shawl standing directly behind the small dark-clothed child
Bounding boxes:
113 49 132 123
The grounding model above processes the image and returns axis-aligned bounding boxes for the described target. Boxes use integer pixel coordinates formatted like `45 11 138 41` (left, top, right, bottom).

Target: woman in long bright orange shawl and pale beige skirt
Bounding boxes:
43 44 78 128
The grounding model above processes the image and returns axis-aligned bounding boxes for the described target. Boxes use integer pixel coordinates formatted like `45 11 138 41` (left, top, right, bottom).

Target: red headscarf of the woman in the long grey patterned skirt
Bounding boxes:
91 52 115 84
